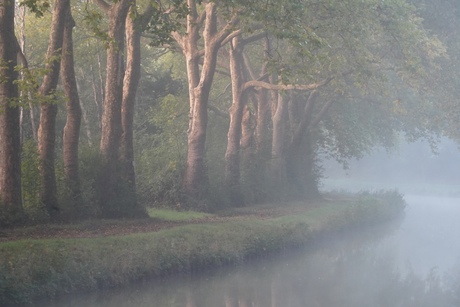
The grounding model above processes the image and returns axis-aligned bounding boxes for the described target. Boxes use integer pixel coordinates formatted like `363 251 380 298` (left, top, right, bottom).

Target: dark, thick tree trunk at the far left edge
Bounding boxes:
0 0 23 226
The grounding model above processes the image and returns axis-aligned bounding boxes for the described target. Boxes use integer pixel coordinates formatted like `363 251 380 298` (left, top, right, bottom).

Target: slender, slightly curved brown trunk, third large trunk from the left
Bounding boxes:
61 6 81 203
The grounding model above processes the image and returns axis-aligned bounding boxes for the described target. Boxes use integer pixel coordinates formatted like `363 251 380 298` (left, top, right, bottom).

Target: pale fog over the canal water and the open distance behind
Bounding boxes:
36 140 460 307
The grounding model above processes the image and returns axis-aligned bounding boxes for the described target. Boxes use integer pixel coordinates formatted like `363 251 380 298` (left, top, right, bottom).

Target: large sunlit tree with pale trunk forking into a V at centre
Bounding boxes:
174 0 314 207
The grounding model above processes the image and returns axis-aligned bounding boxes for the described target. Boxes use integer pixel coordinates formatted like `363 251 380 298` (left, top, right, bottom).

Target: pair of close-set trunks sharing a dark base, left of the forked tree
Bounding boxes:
91 0 181 217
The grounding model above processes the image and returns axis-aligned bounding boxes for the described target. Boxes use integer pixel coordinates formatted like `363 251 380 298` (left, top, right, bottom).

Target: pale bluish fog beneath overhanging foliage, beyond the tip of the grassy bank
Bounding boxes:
322 139 460 196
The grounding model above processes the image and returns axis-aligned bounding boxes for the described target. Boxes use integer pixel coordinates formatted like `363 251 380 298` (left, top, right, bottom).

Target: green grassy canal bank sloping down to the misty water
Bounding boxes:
0 193 404 306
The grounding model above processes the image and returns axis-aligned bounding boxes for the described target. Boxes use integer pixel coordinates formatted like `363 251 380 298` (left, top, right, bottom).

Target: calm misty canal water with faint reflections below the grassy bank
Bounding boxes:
36 195 460 307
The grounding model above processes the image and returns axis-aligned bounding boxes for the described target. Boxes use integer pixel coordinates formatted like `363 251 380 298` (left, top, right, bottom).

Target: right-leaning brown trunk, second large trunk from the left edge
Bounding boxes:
38 0 70 218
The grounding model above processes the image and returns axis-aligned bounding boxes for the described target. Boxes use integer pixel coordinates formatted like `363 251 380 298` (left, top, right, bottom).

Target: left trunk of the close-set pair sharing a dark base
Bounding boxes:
98 0 130 217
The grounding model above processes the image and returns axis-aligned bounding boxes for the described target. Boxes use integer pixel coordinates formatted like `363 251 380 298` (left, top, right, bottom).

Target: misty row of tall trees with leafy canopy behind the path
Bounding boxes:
0 0 460 227
